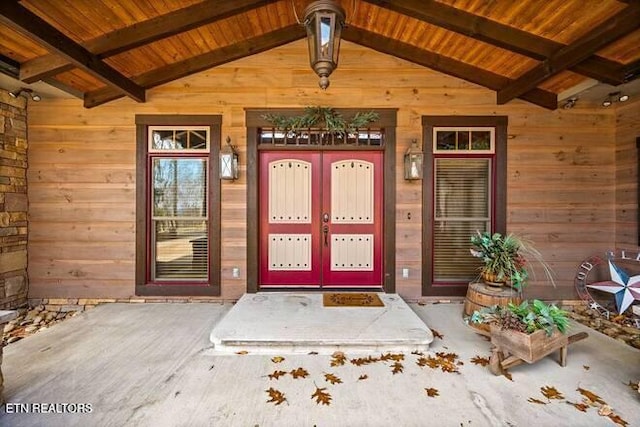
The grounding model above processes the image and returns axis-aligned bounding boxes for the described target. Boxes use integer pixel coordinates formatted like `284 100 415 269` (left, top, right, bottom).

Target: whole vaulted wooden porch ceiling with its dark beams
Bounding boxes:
0 0 640 109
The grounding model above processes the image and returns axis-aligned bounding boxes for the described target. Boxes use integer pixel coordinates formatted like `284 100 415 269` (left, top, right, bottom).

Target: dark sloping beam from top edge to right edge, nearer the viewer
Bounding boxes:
364 0 623 85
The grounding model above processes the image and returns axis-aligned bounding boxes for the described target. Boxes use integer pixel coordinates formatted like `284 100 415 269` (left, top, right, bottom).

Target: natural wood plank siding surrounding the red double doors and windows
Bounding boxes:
28 40 640 299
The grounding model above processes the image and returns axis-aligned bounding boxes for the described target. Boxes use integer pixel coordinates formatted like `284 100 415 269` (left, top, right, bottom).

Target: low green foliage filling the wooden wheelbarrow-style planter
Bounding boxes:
470 299 569 335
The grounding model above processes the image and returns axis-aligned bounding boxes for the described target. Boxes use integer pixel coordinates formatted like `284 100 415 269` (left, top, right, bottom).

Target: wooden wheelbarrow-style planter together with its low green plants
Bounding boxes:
471 300 569 366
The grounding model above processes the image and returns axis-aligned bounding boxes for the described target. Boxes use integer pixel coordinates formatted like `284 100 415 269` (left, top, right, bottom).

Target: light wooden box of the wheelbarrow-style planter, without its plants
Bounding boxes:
490 325 569 363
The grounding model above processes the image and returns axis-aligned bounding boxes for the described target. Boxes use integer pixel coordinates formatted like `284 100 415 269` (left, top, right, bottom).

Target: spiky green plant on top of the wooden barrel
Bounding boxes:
470 231 555 291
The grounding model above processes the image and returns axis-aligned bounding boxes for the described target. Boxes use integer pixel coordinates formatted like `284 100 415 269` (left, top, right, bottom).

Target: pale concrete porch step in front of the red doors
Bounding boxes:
210 292 433 354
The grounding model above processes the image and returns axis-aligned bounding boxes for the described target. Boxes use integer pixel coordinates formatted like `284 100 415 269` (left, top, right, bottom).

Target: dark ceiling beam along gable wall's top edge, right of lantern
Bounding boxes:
343 26 558 110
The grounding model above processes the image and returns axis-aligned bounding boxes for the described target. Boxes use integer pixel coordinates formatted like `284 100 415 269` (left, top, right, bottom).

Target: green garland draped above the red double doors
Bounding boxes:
261 107 380 135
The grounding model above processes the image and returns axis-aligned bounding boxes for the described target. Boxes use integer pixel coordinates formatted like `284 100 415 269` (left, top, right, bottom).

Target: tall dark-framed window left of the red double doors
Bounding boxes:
136 116 220 295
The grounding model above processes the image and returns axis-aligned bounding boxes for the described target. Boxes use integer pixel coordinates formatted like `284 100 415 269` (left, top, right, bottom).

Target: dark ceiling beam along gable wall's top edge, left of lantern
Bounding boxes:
84 24 306 108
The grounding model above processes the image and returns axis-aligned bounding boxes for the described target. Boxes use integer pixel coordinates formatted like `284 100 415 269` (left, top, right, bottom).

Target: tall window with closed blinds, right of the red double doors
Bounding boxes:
423 117 506 295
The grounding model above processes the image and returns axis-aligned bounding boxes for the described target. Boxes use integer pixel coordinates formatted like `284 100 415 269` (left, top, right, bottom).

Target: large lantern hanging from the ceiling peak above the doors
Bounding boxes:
304 0 345 89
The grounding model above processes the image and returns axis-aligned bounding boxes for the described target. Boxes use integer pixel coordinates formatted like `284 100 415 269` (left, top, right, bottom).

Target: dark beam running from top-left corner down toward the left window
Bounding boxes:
0 0 145 102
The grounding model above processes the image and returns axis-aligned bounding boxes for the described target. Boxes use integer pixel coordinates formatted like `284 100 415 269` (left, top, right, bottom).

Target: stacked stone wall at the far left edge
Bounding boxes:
0 89 28 309
